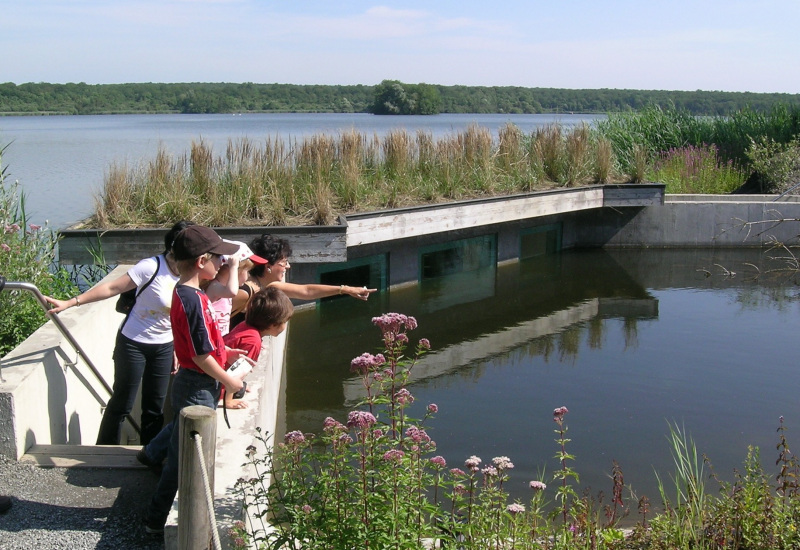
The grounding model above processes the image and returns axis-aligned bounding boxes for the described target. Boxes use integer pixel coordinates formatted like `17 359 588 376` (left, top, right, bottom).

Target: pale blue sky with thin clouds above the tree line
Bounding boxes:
0 0 800 94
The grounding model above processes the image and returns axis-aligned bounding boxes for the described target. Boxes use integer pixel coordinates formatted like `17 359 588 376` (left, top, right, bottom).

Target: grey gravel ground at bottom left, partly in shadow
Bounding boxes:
0 457 164 550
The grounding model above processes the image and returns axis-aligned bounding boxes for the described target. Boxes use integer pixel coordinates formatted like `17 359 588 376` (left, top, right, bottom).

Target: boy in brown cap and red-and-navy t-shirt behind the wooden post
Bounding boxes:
145 225 243 533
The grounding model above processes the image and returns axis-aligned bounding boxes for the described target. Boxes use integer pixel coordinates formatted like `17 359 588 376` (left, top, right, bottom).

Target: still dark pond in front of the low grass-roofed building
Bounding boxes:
286 250 800 508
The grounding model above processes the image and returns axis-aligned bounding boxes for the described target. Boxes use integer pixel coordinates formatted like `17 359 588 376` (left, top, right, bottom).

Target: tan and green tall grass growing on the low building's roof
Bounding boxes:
91 124 624 227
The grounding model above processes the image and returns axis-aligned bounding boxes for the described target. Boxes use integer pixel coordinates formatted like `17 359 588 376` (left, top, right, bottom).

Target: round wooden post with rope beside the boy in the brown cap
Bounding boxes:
178 405 217 550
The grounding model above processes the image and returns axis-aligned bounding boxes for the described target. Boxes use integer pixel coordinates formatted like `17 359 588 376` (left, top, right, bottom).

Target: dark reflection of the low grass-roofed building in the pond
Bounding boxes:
287 251 658 432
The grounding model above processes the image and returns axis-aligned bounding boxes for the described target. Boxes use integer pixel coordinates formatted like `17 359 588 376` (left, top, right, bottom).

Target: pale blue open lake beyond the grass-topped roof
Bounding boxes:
0 113 603 229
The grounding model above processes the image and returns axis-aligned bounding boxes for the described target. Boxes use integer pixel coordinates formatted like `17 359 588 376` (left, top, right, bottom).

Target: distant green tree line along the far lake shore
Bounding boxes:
0 80 800 115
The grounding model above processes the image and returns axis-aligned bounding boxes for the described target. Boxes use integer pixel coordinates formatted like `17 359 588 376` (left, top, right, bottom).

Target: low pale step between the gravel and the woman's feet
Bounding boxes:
19 445 144 470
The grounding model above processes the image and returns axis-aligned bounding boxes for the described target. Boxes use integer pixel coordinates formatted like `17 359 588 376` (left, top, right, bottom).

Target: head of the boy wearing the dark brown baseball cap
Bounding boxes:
172 225 239 279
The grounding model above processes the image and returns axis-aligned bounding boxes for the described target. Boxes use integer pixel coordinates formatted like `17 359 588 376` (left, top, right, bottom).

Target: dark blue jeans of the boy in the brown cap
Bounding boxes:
145 369 220 526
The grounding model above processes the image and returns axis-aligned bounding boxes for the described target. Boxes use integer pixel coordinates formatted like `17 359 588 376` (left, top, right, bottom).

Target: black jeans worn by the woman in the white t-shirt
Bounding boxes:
97 332 173 445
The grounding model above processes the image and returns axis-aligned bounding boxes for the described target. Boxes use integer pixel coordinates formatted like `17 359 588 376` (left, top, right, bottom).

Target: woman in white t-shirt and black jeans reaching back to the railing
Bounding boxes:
45 221 194 445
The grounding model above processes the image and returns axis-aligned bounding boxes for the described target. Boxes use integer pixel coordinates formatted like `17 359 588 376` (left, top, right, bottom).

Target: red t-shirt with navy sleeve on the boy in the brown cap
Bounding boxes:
169 285 227 372
